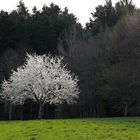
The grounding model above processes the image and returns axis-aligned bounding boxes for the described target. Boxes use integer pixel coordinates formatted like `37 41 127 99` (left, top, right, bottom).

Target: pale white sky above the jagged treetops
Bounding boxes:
0 0 140 26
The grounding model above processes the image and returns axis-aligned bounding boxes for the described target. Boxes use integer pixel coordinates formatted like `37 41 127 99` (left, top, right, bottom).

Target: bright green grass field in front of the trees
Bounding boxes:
0 118 140 140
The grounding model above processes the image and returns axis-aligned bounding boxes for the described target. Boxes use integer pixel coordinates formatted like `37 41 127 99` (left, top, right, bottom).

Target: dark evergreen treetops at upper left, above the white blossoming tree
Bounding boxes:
0 1 81 53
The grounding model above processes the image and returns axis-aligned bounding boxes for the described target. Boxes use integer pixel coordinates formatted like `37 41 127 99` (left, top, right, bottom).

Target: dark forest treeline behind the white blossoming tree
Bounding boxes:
0 0 140 119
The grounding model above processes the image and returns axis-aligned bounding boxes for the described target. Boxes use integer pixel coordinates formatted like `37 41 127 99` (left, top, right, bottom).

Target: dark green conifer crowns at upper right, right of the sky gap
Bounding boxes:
87 0 135 35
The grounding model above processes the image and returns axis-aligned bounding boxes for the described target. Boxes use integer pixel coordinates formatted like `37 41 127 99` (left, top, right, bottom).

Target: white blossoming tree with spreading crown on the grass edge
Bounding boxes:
2 54 79 119
